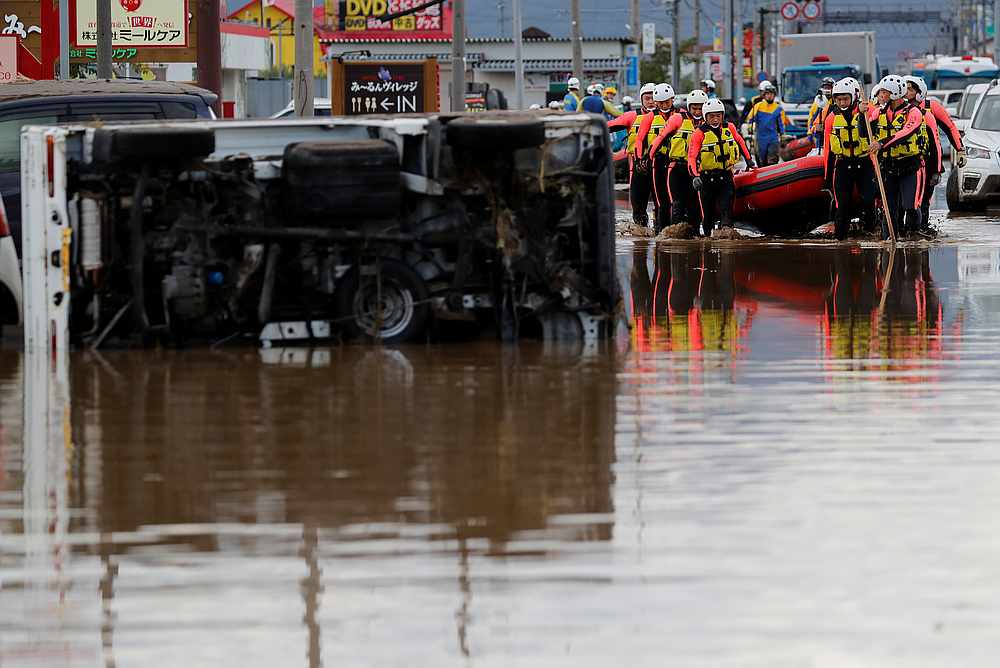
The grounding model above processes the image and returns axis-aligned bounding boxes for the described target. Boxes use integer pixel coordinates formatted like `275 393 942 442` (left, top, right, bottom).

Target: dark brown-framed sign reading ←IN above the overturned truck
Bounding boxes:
331 58 438 116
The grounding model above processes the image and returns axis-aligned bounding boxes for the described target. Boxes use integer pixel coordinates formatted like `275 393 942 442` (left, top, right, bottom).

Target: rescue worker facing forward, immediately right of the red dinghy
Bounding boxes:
823 79 875 239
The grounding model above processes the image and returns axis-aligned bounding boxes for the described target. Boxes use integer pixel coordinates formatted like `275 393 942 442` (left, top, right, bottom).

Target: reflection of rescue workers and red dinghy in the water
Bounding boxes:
630 244 962 380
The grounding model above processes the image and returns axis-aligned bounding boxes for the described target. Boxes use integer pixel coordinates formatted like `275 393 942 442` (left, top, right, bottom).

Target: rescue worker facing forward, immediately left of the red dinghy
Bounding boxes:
688 100 754 236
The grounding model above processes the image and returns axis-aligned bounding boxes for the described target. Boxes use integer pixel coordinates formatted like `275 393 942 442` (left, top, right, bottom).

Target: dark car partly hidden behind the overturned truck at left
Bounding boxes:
0 79 217 253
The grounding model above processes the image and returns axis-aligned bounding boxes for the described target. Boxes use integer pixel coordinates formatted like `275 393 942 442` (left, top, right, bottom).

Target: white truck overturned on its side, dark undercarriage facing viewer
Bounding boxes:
22 114 619 346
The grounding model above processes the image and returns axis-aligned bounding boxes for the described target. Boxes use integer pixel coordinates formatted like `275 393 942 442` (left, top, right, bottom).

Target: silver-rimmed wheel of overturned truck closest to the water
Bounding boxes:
334 259 431 343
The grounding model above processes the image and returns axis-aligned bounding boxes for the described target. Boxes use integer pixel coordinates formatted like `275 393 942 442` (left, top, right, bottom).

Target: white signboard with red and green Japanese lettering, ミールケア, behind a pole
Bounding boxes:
73 0 188 49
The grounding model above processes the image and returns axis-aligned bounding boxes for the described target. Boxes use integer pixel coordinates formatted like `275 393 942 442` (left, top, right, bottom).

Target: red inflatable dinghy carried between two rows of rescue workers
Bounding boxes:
733 155 830 219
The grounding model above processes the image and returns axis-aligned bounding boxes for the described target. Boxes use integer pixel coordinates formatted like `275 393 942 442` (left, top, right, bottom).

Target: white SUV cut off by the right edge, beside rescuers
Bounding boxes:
945 84 1000 211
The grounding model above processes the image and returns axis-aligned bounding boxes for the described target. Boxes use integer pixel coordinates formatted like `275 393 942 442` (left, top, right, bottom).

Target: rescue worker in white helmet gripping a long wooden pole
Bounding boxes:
869 77 928 237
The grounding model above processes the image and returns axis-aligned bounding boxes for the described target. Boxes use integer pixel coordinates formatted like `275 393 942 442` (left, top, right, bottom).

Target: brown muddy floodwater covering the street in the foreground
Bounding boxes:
0 196 1000 668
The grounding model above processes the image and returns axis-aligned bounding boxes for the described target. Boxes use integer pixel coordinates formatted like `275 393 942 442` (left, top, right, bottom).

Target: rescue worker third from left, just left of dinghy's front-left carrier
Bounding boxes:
649 90 708 230
